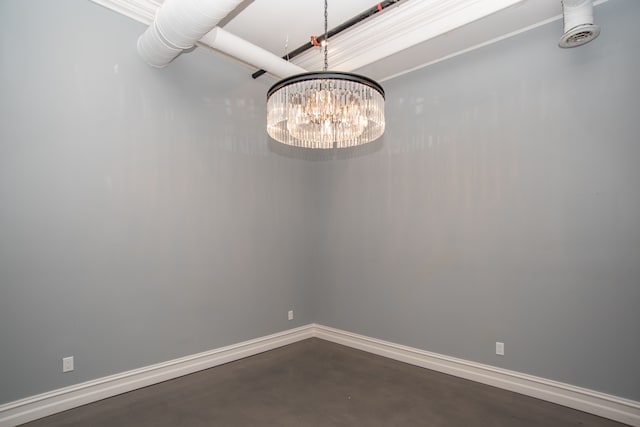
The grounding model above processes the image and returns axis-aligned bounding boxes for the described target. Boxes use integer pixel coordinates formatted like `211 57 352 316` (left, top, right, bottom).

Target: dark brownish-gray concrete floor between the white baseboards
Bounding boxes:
27 338 621 427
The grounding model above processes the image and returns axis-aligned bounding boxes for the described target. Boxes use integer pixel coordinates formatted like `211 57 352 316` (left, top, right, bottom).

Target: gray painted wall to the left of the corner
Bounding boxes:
0 0 314 403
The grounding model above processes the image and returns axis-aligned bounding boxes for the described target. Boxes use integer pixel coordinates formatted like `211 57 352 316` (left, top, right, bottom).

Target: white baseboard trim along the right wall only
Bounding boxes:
313 324 640 426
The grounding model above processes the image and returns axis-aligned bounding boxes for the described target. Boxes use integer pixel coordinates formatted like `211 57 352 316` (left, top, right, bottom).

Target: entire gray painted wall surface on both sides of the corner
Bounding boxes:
0 0 640 410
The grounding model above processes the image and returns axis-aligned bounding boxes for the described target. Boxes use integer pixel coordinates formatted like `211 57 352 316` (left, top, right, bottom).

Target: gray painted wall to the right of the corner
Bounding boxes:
313 0 640 400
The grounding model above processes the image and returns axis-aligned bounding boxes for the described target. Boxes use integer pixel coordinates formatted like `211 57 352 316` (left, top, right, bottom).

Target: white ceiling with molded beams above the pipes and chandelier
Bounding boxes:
93 0 607 81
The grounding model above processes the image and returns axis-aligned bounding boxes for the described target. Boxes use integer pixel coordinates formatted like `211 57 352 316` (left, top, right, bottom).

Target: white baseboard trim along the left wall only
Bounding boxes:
0 325 313 427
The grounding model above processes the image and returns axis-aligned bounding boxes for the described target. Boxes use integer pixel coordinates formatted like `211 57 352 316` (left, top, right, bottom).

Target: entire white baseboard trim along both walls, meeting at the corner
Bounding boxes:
0 324 640 427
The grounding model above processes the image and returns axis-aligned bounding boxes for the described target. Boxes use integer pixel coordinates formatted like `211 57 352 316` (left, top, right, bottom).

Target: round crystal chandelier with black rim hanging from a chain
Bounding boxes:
267 0 384 148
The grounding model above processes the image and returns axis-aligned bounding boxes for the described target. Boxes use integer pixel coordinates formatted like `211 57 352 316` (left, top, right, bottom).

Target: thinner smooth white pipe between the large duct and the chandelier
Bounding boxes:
200 27 307 78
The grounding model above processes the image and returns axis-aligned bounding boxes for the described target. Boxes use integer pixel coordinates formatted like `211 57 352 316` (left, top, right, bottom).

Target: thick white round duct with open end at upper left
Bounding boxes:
138 0 243 67
